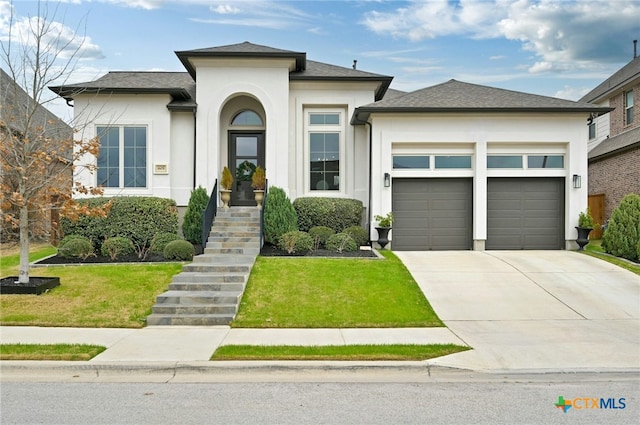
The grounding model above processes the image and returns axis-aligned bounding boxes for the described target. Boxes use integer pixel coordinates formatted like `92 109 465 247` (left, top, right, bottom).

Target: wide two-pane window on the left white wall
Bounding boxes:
96 126 147 188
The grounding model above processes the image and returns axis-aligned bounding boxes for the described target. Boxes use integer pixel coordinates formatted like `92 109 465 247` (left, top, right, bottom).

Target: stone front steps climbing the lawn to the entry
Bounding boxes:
147 207 260 326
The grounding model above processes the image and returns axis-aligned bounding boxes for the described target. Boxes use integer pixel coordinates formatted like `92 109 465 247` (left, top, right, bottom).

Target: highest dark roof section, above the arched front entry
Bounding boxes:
175 41 307 80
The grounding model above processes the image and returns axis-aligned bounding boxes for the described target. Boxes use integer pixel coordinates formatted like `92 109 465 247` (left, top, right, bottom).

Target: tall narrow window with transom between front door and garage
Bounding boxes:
307 112 343 191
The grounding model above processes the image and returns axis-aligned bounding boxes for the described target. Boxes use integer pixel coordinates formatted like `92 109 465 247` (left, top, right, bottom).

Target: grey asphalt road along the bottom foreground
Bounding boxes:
0 373 640 425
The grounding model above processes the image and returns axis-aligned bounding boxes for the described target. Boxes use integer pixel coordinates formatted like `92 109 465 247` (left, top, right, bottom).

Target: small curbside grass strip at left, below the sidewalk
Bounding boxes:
0 344 106 361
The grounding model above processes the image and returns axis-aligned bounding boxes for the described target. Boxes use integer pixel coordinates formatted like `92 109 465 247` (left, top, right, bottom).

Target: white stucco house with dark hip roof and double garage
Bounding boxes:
51 42 609 250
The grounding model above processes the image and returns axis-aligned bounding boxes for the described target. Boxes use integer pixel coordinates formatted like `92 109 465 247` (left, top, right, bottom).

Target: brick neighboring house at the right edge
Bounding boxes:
580 55 640 232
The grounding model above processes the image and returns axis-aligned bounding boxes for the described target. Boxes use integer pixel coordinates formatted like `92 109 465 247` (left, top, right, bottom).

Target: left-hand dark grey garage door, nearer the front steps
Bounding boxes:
392 179 473 251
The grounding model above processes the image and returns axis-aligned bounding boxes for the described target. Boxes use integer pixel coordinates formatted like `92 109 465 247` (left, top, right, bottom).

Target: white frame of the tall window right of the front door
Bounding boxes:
304 107 346 196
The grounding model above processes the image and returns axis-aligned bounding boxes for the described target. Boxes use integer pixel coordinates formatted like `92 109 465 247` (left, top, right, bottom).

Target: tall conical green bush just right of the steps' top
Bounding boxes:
264 186 298 245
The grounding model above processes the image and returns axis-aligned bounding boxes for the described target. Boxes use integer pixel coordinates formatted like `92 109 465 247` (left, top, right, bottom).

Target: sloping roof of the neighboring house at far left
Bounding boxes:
0 68 72 138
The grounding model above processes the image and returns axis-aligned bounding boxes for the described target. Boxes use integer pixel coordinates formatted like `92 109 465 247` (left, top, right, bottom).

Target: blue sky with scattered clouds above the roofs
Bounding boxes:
0 0 640 119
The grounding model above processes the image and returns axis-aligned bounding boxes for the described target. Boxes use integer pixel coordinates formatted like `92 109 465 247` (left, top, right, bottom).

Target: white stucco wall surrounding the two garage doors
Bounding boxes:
371 114 588 249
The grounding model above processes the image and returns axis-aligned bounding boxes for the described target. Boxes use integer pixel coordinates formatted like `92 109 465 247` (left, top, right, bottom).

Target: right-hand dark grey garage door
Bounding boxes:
485 178 564 249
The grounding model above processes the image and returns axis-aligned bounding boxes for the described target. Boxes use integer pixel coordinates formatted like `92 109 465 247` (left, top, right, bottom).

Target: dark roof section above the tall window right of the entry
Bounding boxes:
289 61 393 100
